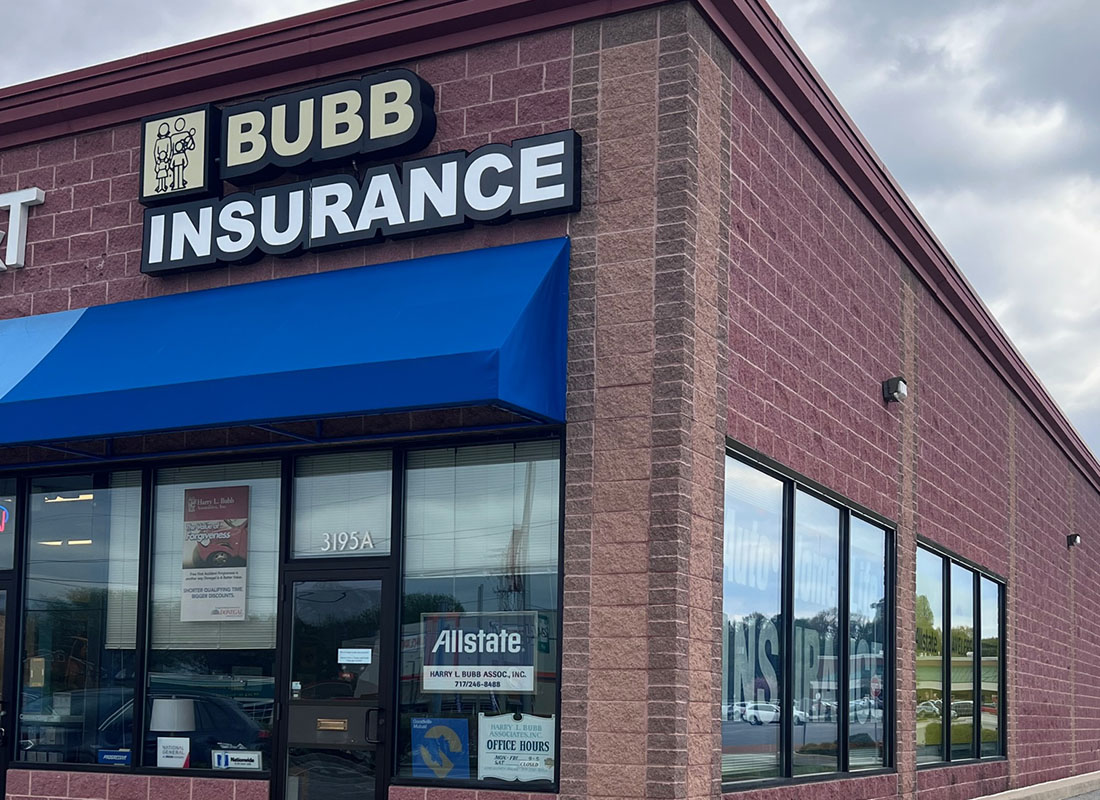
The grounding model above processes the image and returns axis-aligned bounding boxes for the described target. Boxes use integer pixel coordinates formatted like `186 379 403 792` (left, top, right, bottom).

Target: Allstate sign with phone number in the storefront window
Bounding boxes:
420 611 538 694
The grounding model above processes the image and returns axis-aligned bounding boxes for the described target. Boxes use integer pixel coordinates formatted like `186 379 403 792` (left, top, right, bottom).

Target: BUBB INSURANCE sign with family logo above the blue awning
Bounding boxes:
141 69 581 274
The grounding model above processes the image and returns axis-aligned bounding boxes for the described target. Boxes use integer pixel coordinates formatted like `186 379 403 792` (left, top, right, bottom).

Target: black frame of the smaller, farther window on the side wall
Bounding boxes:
914 535 1009 770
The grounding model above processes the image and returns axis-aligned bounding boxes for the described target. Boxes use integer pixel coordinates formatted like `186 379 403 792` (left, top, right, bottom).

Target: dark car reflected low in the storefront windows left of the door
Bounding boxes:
19 688 271 766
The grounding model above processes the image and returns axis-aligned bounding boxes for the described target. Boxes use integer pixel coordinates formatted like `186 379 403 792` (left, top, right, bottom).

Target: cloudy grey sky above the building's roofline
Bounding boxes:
0 0 1100 453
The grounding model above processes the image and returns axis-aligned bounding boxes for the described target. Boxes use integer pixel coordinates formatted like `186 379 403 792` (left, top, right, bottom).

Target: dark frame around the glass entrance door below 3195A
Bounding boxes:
271 557 399 800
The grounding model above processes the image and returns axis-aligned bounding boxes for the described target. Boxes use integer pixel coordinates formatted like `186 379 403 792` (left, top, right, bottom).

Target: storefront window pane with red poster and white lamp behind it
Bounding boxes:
142 461 281 769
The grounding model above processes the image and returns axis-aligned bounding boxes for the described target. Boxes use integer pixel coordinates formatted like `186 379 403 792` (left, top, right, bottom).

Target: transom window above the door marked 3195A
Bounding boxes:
294 451 393 558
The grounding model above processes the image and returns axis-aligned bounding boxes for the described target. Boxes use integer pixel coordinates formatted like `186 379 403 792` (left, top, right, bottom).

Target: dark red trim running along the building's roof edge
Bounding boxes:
0 0 1100 492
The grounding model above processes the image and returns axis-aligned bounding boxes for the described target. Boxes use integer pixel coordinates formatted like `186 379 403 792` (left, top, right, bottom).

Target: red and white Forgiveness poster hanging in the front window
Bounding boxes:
179 486 249 622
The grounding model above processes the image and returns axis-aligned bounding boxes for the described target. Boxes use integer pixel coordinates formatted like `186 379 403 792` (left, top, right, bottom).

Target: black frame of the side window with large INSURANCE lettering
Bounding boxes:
719 439 898 792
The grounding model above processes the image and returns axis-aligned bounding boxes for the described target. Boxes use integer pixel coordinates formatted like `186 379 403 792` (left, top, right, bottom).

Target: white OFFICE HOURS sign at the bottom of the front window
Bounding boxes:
477 713 556 780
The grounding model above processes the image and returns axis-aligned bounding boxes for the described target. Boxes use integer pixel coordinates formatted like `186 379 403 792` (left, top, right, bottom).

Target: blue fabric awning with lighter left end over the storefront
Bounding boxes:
0 239 569 445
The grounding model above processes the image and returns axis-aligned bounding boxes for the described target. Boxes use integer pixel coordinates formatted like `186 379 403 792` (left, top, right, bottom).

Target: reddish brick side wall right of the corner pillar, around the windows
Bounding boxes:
712 0 1100 800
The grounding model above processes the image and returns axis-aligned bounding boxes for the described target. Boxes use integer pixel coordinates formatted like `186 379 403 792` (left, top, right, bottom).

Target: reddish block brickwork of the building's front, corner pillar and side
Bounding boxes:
0 3 1100 800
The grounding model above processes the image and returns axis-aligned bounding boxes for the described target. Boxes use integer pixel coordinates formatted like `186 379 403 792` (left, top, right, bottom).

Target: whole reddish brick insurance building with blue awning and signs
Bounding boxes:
0 0 1100 800
